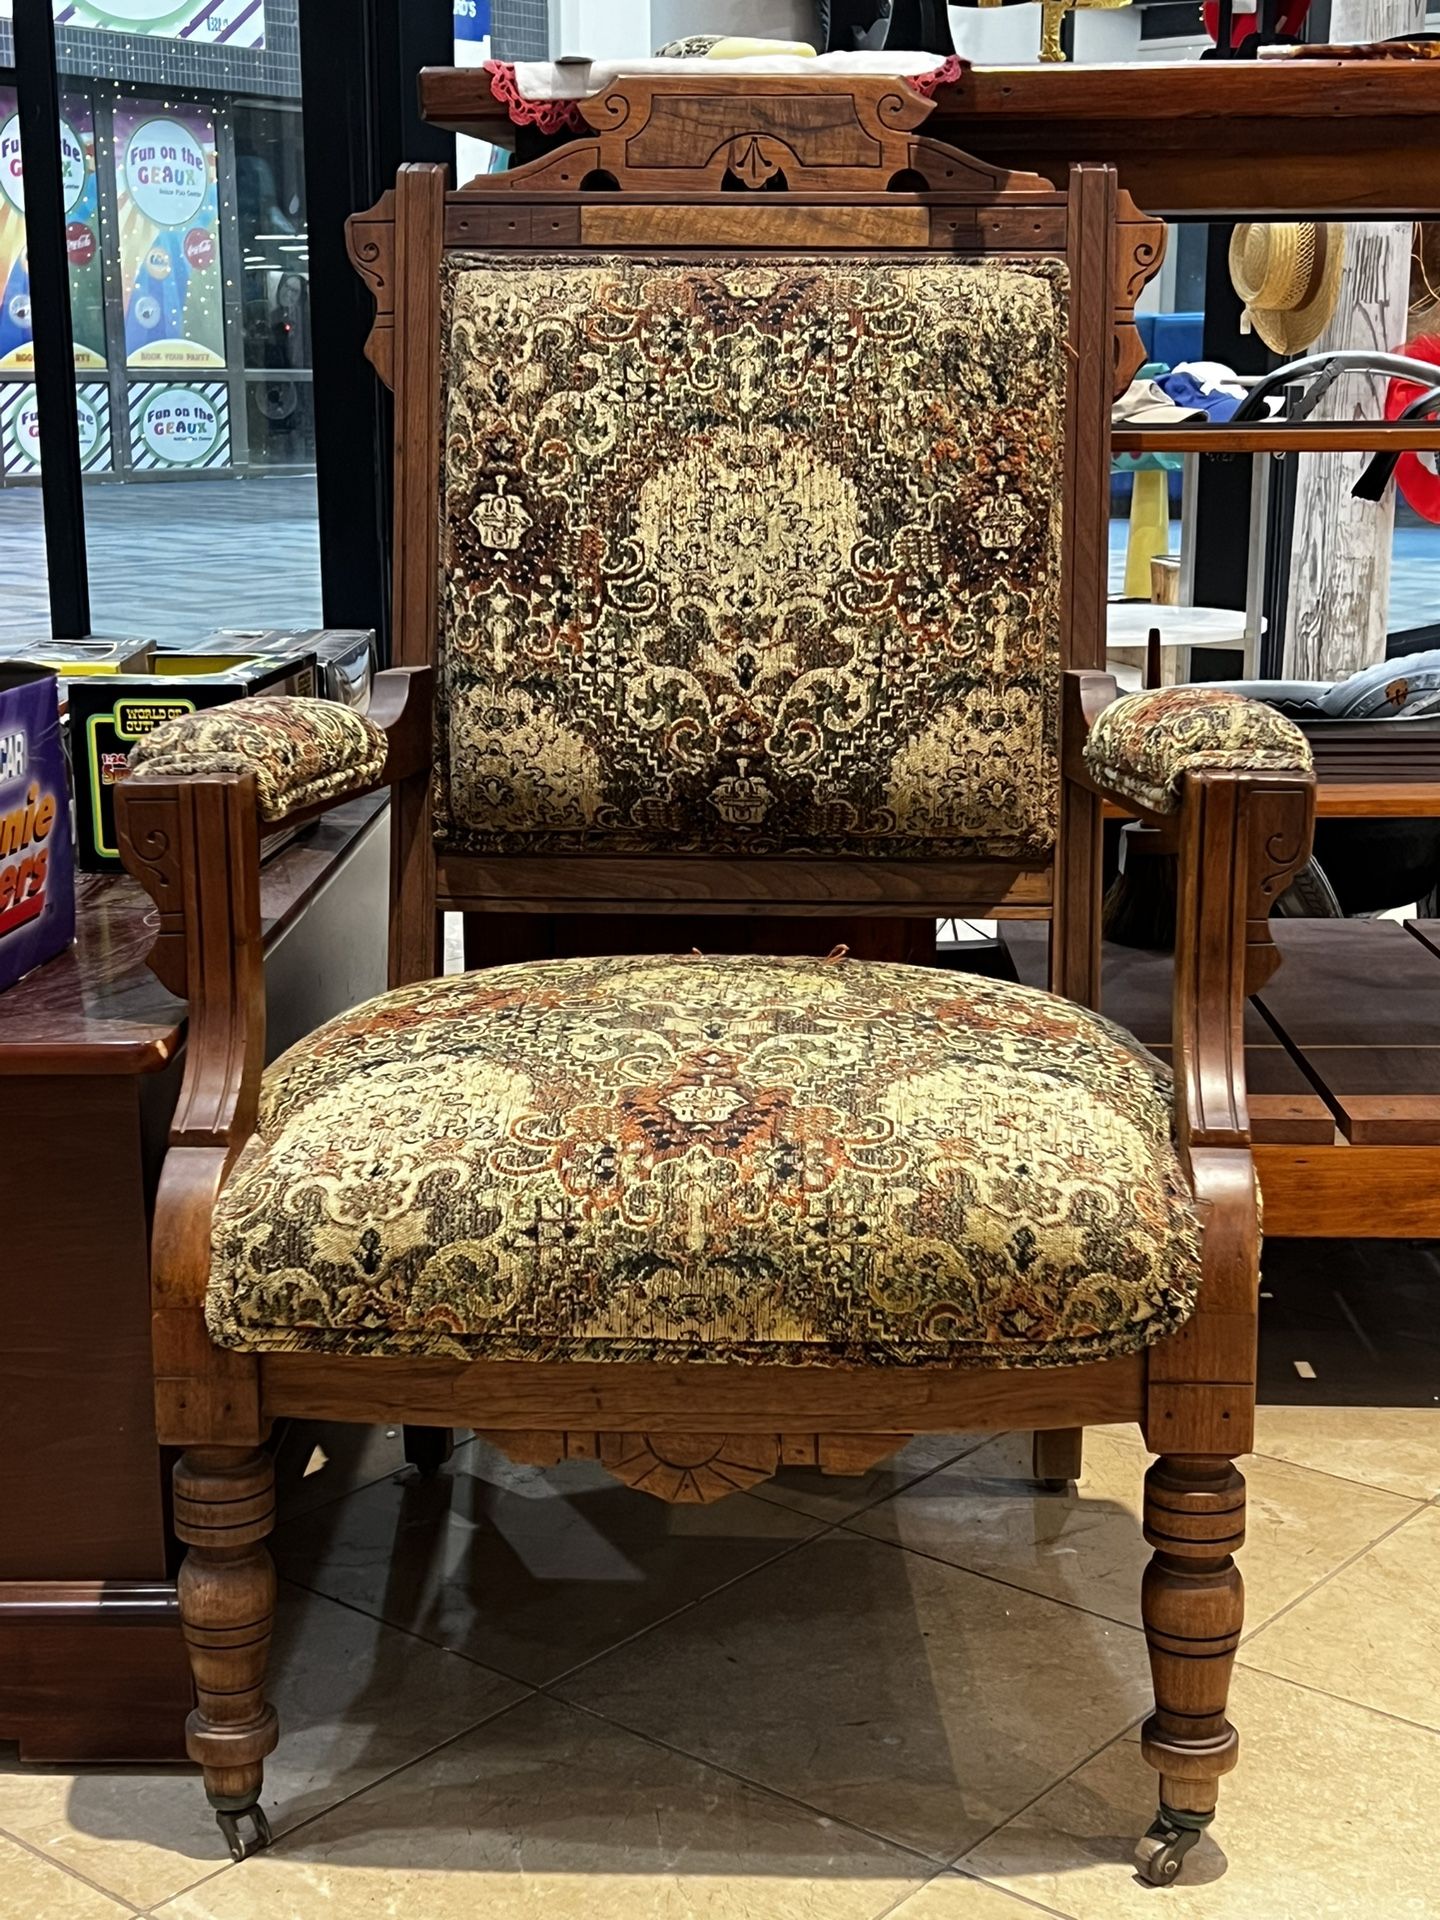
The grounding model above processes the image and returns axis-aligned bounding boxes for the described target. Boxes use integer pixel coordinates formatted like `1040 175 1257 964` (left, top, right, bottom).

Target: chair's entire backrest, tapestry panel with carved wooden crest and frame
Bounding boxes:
351 63 1160 906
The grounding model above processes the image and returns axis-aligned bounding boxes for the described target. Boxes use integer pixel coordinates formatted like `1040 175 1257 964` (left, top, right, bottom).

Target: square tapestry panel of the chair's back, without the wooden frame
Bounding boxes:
434 252 1068 866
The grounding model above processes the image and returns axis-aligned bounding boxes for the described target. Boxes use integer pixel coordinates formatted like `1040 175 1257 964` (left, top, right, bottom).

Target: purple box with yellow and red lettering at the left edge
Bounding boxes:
0 664 75 991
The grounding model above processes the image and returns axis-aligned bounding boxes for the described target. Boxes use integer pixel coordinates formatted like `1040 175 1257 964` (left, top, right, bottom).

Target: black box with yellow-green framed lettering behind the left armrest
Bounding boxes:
67 653 315 874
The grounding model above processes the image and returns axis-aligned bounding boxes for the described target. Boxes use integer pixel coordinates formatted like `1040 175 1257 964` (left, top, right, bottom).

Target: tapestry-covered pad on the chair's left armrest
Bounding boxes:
131 693 386 820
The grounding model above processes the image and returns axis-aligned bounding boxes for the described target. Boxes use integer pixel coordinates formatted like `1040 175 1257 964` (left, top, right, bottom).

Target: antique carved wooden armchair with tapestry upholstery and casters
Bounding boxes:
119 71 1311 1882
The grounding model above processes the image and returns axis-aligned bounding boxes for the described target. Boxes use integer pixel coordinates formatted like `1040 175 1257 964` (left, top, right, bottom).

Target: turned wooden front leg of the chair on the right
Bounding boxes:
1140 1455 1244 1826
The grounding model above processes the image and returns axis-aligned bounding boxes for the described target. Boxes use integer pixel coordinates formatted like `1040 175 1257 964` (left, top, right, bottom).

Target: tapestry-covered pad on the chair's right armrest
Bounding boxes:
1085 687 1311 814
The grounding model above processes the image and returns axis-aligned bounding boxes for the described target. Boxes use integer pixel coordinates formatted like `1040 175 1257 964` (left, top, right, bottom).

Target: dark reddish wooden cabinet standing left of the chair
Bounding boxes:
0 799 390 1761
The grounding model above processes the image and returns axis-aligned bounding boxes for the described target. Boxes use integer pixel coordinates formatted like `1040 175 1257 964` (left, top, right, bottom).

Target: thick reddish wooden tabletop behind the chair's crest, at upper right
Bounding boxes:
420 60 1440 219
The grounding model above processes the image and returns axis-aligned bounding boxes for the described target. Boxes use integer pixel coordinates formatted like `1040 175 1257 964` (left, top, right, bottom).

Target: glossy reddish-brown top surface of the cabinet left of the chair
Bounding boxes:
0 795 386 1075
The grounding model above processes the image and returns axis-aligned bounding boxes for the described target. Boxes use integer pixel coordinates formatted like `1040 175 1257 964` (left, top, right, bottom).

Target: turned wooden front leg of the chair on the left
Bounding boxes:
175 1448 278 1812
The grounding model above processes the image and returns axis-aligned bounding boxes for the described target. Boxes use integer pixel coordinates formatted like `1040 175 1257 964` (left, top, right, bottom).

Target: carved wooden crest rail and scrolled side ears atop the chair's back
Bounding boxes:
348 63 1165 394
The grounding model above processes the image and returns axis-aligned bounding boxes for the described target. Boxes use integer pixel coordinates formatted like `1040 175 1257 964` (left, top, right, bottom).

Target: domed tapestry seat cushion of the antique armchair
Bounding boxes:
207 956 1200 1367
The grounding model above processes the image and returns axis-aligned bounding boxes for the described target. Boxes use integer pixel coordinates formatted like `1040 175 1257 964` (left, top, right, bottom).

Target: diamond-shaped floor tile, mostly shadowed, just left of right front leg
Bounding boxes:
561 1530 1150 1859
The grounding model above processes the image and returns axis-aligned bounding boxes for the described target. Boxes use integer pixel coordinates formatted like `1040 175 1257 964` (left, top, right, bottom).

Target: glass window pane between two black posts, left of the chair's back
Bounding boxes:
45 0 321 639
